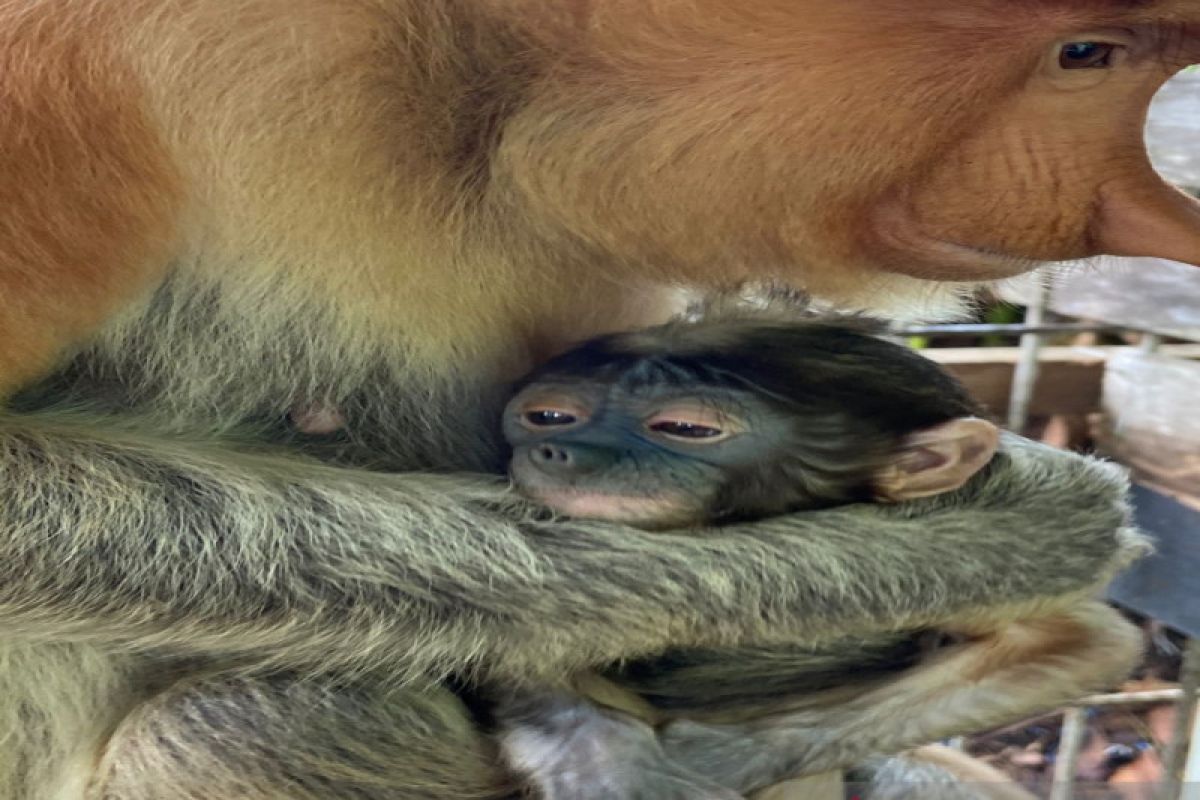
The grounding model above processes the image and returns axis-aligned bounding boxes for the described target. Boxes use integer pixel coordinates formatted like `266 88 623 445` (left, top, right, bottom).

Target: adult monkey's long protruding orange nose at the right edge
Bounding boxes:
1091 172 1200 266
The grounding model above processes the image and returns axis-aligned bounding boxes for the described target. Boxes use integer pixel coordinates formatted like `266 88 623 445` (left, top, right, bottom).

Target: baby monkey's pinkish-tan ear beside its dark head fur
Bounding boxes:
875 416 1000 503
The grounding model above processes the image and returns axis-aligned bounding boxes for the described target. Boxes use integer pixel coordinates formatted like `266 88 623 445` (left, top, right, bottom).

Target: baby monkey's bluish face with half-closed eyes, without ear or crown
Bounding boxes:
504 380 787 528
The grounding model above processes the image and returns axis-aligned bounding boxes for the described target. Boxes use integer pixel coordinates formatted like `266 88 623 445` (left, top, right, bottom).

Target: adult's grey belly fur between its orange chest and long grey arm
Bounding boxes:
12 282 509 473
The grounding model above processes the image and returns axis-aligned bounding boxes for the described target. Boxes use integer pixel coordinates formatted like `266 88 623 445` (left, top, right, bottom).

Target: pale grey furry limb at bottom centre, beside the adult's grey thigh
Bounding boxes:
494 688 742 800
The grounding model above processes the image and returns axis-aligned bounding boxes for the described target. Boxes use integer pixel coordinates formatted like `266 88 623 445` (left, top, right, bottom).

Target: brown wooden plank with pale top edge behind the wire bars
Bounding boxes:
922 345 1200 419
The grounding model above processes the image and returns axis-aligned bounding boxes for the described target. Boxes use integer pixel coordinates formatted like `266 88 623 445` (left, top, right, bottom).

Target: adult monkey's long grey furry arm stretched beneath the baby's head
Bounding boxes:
0 416 1130 676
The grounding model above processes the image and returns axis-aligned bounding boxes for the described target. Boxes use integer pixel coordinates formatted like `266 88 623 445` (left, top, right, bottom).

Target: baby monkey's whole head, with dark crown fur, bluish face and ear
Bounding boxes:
504 318 996 528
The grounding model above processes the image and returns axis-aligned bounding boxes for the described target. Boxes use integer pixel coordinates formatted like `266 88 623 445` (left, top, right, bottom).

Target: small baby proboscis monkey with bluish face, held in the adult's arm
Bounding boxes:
498 317 1134 800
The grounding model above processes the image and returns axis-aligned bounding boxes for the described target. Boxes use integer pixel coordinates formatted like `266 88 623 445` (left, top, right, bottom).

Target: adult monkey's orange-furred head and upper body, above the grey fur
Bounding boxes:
0 0 1200 398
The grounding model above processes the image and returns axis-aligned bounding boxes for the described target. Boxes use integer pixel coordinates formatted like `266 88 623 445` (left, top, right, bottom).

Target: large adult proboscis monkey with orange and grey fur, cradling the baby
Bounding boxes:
0 0 1200 800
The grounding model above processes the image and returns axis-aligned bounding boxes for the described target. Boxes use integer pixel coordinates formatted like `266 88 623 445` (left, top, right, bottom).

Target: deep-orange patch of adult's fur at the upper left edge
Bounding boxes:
0 2 180 391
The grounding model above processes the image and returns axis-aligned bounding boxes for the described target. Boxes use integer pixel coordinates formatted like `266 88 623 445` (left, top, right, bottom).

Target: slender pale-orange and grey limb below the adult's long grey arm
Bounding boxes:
660 601 1141 793
